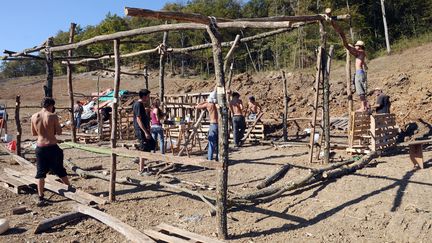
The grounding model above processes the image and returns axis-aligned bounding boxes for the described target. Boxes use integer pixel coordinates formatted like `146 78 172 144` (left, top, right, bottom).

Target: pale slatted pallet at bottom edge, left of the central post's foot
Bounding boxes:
144 223 226 243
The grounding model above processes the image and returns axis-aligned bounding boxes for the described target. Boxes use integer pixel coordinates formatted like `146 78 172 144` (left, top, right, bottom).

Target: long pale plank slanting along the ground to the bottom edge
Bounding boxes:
72 204 154 243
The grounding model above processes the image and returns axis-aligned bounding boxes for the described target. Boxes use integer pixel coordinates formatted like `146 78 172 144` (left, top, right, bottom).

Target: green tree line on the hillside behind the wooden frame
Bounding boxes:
0 0 432 77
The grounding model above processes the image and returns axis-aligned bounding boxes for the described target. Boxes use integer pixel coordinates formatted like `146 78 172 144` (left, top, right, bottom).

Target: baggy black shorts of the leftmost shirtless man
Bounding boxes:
35 144 67 179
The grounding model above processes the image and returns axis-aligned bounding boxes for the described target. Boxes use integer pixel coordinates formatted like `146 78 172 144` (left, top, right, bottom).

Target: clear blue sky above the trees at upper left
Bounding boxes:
0 0 176 52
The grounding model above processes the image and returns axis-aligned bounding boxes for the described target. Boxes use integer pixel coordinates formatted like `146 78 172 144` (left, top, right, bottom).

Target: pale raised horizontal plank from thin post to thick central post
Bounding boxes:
112 148 221 169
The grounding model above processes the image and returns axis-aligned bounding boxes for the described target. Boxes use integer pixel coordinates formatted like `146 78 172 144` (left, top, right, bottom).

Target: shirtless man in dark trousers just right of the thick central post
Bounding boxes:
229 92 246 147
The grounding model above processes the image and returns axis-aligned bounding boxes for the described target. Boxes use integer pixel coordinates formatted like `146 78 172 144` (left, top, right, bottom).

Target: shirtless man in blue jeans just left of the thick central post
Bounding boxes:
195 91 219 161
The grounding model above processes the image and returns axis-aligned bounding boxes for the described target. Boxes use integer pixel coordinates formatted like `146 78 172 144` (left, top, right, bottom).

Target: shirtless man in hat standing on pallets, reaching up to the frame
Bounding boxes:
331 21 370 111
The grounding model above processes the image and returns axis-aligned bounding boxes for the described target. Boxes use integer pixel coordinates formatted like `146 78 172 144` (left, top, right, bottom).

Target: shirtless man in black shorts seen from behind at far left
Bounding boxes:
31 97 70 206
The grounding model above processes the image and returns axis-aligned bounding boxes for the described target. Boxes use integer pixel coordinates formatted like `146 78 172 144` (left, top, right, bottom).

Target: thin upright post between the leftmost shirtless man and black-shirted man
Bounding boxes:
109 39 120 202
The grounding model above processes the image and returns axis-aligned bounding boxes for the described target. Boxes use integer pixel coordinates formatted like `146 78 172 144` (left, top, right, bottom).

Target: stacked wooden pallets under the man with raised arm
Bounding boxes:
347 111 399 153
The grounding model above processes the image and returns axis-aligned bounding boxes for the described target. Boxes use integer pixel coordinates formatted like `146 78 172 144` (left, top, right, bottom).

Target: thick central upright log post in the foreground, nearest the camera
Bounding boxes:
207 18 229 239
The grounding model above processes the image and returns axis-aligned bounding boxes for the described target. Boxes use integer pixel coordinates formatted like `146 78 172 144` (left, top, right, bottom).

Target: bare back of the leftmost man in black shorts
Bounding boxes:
31 109 62 147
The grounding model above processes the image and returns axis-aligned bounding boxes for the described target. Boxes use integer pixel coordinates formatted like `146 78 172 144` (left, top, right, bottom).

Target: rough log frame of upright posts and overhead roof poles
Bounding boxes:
2 8 349 239
